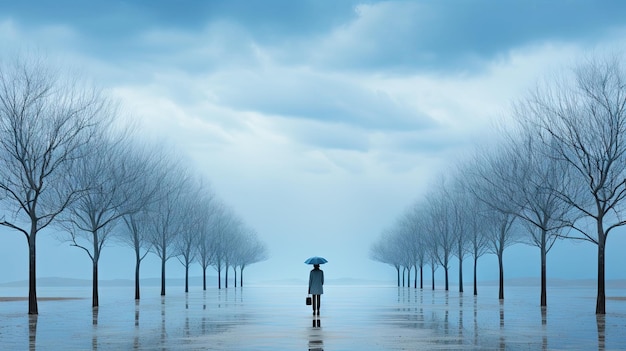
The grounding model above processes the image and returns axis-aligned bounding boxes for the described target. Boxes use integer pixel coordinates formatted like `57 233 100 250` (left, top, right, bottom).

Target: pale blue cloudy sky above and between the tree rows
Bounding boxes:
0 0 626 288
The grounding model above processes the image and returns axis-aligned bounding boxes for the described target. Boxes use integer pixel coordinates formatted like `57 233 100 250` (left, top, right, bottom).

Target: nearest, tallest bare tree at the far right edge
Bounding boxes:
524 57 626 314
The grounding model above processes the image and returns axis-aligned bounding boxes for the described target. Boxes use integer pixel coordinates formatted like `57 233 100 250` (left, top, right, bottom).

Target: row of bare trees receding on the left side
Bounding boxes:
0 57 267 314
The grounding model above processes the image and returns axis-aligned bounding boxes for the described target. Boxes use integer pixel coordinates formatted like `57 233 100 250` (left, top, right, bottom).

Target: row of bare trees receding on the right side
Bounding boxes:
370 55 626 314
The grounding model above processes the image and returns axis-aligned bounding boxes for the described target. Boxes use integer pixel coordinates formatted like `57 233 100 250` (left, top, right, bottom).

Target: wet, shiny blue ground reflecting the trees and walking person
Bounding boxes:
0 286 626 351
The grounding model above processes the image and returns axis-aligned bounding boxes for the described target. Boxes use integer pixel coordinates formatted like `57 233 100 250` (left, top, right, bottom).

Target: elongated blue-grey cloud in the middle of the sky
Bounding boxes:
207 62 431 130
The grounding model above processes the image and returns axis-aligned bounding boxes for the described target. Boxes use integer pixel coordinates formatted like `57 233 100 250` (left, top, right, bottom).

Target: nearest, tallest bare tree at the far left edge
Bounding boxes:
0 58 111 314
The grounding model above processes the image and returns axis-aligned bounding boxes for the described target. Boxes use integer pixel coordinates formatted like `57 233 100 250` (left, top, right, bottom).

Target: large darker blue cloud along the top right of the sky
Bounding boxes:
276 0 626 75
